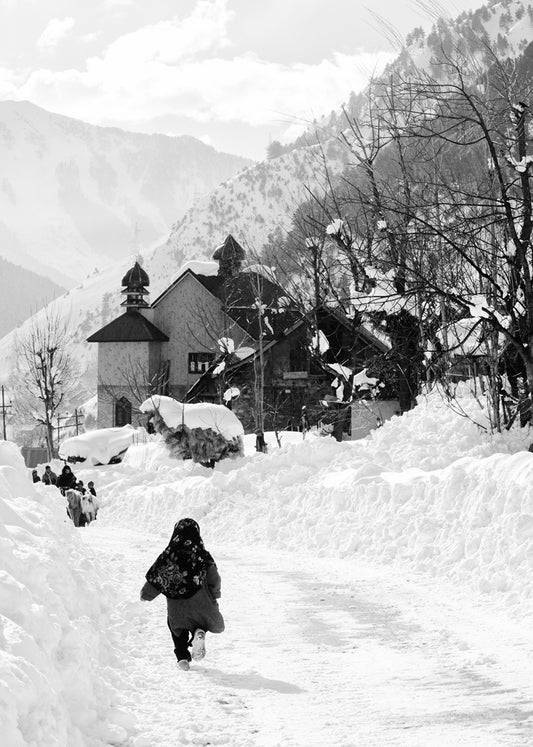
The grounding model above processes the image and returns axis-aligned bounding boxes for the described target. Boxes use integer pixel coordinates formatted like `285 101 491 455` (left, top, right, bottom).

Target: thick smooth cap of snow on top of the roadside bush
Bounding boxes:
140 394 244 440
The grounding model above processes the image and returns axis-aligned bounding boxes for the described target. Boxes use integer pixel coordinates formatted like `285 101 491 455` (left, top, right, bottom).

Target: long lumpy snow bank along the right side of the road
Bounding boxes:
97 394 533 613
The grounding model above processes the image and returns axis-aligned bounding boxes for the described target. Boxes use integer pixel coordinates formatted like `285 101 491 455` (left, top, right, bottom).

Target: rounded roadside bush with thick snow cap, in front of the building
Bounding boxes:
140 395 244 466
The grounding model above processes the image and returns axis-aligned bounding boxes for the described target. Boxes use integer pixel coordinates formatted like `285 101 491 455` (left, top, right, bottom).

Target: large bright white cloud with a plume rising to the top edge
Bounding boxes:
7 0 391 134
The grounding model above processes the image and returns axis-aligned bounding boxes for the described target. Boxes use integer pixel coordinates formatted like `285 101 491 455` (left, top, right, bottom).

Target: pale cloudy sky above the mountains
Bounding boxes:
0 0 482 159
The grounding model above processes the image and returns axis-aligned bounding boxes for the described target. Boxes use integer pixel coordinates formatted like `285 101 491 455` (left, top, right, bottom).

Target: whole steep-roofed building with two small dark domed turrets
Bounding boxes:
88 235 390 435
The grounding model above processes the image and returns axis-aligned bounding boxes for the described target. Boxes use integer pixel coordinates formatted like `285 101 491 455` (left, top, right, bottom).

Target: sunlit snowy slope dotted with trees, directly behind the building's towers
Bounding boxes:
0 146 345 393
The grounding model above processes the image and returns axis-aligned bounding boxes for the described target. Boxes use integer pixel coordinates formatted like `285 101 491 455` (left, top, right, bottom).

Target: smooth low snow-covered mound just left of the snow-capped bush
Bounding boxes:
59 425 137 465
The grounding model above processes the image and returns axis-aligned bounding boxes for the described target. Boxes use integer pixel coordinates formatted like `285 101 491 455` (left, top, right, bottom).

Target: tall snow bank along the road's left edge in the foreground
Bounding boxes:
0 441 137 747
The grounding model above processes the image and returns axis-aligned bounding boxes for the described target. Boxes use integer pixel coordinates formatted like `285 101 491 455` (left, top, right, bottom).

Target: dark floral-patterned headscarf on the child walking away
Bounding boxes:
146 519 214 599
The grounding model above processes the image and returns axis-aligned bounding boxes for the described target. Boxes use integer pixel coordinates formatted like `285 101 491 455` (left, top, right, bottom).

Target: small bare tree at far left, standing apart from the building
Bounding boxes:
13 307 76 459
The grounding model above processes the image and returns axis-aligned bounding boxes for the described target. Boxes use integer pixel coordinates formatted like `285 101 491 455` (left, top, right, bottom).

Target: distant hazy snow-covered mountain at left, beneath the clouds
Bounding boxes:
0 101 250 286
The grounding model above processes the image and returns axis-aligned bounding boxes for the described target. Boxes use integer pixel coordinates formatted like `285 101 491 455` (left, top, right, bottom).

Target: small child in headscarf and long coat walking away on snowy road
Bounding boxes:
141 519 224 670
